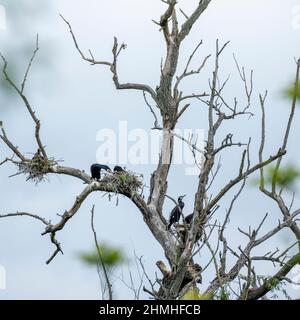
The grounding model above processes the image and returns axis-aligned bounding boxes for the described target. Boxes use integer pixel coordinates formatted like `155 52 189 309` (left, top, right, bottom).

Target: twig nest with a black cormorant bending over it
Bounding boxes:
101 171 143 194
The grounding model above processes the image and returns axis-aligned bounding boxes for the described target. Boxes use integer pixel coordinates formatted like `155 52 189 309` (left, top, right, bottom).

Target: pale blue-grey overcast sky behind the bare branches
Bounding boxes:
0 0 300 299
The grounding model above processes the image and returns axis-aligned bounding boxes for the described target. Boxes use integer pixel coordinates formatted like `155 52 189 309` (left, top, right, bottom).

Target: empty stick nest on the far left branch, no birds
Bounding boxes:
17 150 57 184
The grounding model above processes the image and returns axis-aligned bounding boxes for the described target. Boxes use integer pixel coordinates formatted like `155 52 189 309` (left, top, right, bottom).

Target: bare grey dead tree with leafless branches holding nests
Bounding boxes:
0 0 300 299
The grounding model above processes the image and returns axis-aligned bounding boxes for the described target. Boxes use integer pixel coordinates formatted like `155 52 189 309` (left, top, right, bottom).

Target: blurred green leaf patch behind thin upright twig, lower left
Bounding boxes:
79 244 126 268
